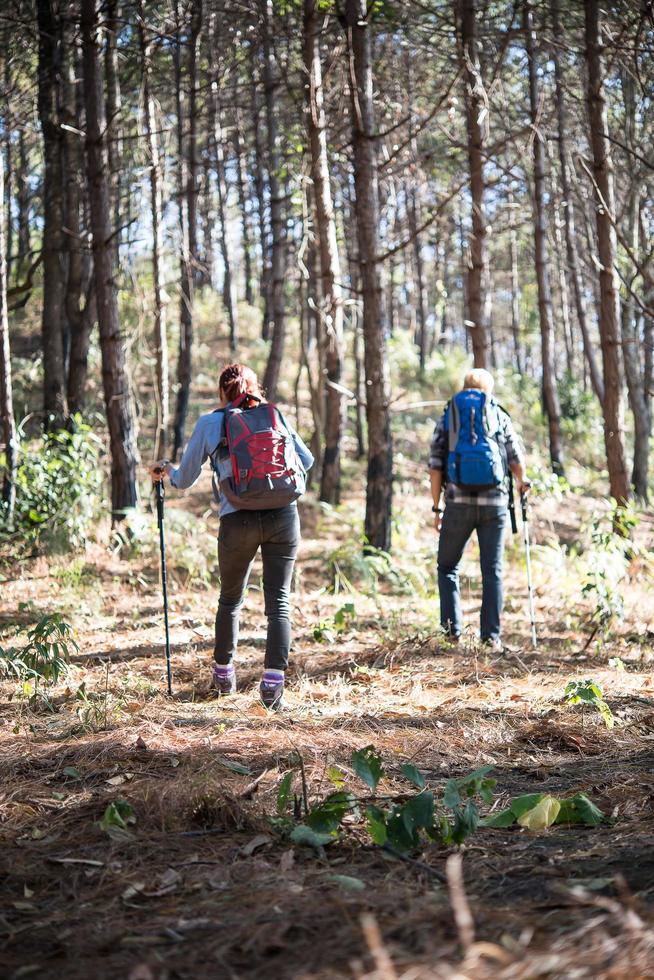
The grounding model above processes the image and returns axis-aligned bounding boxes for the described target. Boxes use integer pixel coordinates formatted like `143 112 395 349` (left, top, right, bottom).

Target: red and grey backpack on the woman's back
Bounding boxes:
211 394 306 510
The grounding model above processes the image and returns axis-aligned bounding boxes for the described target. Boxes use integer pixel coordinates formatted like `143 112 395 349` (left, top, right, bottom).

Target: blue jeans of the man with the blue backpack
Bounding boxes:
438 503 507 640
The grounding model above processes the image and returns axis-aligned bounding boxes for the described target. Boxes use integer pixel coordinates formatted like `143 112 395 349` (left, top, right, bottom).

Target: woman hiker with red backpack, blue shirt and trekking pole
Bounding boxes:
149 364 314 710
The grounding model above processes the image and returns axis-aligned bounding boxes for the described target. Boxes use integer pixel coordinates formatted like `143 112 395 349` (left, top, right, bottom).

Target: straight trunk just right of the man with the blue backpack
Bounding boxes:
523 0 564 476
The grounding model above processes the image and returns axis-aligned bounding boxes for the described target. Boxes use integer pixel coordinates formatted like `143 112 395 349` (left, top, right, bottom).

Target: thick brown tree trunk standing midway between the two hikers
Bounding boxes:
345 0 393 551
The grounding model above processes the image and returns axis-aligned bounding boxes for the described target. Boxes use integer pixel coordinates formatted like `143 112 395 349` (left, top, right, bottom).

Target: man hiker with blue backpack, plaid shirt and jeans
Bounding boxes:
429 368 531 653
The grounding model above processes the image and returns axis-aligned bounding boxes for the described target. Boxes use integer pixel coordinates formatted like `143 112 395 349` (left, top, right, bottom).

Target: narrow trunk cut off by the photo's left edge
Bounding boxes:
0 153 18 526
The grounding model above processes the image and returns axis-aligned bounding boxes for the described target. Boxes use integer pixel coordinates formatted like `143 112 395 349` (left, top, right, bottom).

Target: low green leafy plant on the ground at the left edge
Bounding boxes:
0 613 79 686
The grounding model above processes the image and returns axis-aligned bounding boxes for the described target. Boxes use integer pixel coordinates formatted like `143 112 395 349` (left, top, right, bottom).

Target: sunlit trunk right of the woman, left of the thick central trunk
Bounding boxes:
304 0 345 504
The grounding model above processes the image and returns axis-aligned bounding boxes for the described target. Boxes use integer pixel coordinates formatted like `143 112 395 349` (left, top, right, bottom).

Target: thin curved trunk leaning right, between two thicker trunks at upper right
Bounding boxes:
550 0 604 403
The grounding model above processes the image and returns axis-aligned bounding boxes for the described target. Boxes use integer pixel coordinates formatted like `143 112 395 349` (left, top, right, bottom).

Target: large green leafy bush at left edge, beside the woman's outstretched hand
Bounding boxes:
0 416 102 553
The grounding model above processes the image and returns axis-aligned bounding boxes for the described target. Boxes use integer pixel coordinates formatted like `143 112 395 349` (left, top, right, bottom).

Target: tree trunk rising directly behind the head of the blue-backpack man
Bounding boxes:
460 0 490 368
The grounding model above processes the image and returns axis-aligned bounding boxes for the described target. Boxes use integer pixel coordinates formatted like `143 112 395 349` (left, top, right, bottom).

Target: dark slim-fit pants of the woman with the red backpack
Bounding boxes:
214 504 300 670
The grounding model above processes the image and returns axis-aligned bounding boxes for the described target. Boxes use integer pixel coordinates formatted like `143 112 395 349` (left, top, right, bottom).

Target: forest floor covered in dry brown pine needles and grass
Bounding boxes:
0 472 654 980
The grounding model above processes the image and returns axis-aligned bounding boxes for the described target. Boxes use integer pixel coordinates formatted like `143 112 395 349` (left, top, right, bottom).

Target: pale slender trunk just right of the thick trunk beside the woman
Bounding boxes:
137 0 170 459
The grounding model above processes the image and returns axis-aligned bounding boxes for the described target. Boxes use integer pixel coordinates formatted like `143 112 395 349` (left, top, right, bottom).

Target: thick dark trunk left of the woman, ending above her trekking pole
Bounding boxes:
81 0 137 522
